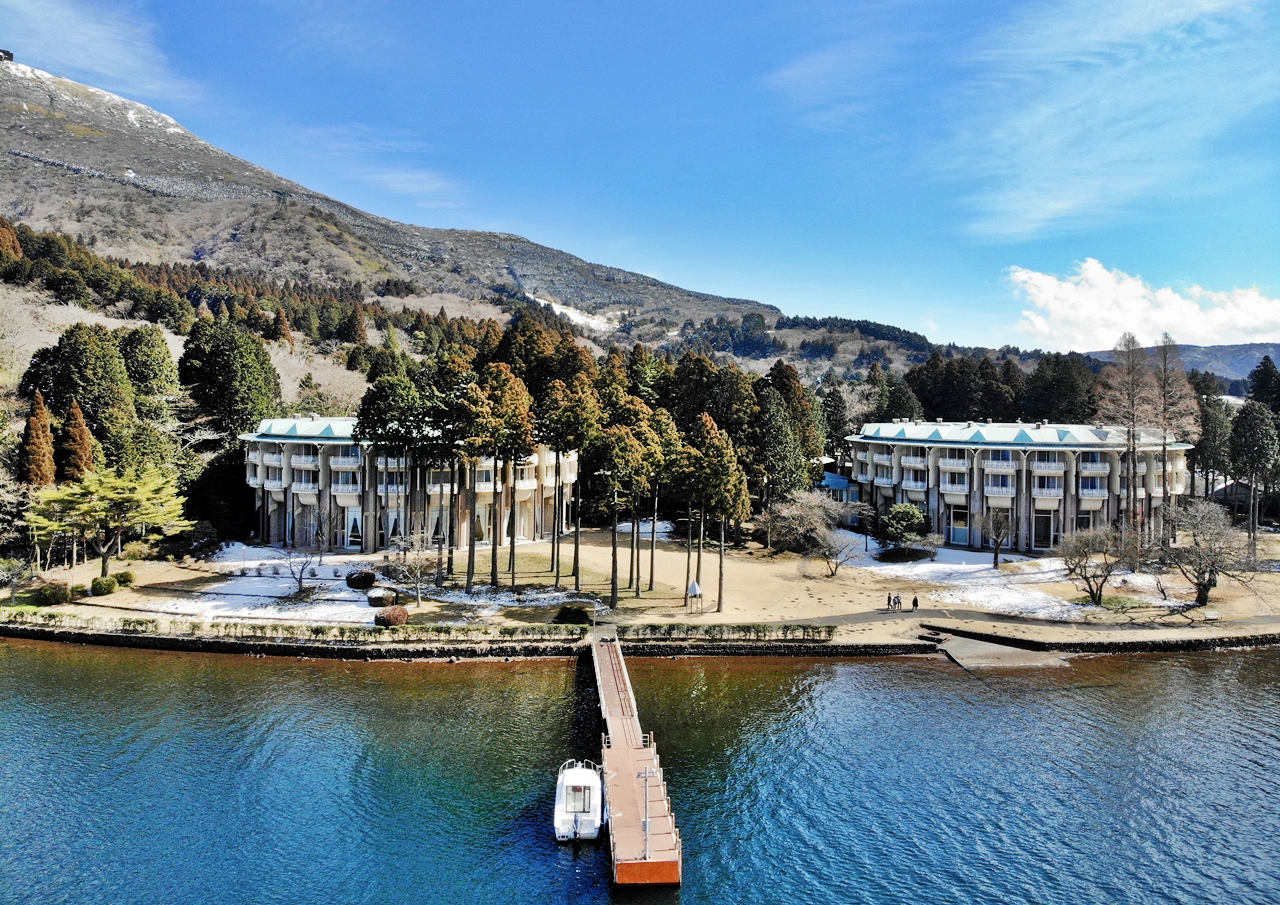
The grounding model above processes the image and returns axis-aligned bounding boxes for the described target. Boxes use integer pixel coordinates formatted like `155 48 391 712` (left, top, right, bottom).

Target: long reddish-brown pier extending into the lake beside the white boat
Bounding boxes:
591 634 682 886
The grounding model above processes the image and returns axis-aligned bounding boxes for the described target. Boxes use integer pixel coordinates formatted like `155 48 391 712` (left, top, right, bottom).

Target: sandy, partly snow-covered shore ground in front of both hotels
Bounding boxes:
17 526 1280 643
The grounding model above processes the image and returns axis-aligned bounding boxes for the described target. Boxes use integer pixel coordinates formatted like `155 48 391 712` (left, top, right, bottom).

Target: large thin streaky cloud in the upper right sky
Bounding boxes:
941 0 1280 241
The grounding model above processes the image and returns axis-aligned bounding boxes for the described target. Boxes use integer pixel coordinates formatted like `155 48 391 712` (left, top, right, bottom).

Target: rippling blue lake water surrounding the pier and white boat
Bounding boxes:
0 643 1280 904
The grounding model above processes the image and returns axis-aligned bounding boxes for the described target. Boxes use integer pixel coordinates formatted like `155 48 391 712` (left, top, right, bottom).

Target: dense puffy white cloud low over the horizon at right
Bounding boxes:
1009 257 1280 352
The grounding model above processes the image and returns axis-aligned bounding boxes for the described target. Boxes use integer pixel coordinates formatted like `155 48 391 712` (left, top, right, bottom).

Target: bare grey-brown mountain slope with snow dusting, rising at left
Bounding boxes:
0 63 781 342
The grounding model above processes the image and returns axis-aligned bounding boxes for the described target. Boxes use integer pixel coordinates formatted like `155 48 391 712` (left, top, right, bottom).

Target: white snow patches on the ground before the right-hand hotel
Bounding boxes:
846 533 1178 622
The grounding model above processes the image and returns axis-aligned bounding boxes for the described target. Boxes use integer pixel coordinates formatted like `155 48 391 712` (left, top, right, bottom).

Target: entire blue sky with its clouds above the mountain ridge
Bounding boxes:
0 0 1280 348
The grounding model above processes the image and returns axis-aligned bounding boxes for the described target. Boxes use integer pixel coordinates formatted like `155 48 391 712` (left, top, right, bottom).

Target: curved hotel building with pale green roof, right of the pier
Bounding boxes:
847 420 1192 552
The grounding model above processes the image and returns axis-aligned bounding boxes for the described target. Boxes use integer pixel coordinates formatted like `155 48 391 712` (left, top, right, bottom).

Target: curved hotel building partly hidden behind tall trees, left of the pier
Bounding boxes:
239 417 577 553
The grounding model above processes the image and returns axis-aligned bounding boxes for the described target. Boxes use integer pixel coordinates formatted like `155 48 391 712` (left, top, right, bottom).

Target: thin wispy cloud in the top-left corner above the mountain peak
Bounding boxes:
0 0 200 100
